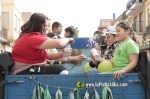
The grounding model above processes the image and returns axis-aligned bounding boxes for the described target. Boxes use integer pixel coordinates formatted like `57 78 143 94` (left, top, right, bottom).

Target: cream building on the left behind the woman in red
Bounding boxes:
1 0 22 52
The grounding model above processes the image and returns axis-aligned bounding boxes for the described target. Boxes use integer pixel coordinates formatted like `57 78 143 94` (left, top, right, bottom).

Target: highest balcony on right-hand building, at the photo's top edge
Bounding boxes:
126 0 144 15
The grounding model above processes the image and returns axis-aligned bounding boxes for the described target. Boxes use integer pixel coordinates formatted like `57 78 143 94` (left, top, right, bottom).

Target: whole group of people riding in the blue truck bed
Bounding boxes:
11 13 139 78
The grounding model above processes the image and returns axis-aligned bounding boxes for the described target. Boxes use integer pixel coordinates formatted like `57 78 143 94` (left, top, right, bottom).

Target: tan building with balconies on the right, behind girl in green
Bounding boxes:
126 0 150 46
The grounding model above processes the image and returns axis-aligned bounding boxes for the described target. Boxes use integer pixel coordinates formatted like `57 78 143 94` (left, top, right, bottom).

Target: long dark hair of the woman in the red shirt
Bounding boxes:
19 13 48 37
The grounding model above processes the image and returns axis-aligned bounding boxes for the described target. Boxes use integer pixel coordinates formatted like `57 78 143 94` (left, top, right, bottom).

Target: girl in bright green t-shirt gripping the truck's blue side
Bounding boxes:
89 21 139 79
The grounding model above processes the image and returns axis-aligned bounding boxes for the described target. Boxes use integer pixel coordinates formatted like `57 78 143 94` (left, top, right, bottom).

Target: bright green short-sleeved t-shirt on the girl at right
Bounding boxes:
113 38 139 71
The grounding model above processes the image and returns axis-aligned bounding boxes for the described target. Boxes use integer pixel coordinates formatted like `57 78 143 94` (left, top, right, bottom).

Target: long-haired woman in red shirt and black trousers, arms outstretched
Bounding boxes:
11 13 74 74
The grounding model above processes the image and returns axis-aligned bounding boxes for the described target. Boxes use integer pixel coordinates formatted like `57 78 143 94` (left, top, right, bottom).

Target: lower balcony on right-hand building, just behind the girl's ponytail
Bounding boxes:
132 21 146 34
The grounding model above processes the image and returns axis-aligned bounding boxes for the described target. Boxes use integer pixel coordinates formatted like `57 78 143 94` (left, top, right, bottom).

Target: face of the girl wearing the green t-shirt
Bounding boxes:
116 26 129 41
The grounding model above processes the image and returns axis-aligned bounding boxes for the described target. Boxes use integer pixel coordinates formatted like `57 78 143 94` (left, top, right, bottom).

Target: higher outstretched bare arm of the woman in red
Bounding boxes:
39 38 74 49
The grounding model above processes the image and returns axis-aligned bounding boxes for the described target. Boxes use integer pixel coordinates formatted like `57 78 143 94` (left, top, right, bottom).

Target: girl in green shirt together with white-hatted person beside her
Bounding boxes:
87 21 139 78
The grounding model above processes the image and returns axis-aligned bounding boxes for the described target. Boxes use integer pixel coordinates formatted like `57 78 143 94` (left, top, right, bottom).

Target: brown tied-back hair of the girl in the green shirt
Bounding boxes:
116 20 138 43
